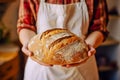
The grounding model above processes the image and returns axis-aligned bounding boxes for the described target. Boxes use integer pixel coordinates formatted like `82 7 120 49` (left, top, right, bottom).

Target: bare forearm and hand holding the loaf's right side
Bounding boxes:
63 31 104 67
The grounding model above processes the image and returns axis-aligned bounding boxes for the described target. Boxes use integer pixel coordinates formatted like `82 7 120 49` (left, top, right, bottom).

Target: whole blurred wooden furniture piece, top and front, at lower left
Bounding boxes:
0 44 19 80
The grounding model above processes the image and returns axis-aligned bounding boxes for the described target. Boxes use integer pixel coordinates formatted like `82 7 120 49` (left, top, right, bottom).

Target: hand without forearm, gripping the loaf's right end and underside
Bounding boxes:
62 45 96 68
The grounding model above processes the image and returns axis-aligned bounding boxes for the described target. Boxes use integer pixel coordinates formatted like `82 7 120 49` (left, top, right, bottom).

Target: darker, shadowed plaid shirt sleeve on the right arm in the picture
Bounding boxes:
88 0 109 40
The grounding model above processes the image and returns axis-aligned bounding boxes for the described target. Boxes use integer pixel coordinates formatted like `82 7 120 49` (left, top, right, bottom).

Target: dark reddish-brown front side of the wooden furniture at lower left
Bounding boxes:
0 56 19 80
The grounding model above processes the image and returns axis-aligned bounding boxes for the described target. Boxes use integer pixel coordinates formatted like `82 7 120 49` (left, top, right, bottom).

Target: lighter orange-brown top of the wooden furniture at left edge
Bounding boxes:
0 43 19 65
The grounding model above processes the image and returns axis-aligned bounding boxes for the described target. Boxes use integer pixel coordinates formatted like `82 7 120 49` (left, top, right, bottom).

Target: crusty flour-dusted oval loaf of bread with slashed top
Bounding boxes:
28 28 88 65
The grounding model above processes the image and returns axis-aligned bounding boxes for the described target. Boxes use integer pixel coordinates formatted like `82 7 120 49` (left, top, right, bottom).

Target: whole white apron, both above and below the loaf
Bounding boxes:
24 0 98 80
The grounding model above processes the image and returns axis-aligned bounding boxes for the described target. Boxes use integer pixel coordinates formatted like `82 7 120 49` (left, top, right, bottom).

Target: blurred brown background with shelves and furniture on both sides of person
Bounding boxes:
0 0 120 80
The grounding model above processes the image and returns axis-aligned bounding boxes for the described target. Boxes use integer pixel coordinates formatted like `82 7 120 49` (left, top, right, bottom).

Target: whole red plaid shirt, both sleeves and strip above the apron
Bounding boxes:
17 0 108 38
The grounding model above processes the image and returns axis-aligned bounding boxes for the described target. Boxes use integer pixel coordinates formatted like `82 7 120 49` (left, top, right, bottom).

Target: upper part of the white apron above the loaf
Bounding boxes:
37 0 89 38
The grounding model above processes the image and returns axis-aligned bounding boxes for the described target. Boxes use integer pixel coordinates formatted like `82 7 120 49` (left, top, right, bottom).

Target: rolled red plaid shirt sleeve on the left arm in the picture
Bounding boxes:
17 0 38 33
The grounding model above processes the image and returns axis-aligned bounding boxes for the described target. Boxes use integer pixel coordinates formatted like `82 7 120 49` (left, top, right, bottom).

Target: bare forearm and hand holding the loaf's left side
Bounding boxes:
19 29 51 66
